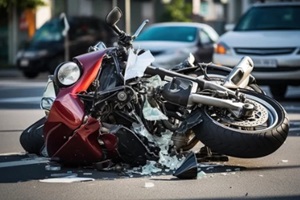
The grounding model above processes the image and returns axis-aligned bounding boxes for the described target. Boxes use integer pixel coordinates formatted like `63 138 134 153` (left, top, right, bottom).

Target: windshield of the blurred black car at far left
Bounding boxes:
32 19 63 42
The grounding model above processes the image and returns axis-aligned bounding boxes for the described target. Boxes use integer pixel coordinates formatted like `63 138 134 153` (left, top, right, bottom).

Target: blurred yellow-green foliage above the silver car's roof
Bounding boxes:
162 0 192 22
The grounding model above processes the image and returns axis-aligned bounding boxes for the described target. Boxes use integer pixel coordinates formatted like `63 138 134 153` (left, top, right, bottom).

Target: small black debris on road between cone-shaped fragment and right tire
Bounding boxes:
196 146 229 162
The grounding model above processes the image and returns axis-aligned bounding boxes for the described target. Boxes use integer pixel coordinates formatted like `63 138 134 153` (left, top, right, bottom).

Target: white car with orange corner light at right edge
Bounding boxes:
213 2 300 99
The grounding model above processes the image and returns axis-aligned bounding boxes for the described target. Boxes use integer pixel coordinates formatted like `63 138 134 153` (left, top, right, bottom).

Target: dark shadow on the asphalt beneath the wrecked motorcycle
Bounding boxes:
0 154 246 183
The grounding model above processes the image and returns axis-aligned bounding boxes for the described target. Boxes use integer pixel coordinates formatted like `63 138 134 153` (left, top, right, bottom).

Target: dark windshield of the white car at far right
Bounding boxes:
234 6 300 31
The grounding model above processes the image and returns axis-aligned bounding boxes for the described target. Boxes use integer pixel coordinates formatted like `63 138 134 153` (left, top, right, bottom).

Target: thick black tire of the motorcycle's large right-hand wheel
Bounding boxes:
193 90 289 158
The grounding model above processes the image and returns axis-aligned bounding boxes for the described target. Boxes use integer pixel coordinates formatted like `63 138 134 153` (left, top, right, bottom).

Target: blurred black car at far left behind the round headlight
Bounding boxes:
17 16 115 78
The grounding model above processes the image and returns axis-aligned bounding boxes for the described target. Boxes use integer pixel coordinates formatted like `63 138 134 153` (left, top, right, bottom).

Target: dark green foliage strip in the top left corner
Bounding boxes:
0 0 45 10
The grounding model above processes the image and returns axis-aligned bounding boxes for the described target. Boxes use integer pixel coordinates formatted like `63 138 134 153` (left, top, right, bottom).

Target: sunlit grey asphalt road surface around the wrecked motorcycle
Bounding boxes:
0 71 300 200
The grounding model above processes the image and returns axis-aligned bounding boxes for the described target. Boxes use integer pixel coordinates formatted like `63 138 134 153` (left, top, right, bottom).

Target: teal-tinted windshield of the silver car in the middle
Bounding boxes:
136 26 197 42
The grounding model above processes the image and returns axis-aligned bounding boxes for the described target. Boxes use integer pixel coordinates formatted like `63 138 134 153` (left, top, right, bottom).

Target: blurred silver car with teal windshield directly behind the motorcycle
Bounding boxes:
133 22 219 69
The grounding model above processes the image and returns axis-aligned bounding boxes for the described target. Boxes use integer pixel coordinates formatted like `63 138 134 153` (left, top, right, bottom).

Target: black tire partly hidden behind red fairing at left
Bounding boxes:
20 117 46 155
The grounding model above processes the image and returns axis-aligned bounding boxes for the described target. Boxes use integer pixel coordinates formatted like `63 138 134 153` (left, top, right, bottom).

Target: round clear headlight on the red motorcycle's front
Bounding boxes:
55 62 81 86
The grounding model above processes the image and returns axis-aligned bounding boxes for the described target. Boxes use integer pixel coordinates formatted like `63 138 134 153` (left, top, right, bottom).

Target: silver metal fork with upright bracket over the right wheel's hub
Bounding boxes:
162 57 254 118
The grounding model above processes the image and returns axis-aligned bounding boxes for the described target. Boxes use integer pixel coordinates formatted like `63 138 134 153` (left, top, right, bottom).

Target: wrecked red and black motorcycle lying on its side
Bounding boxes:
20 8 289 174
